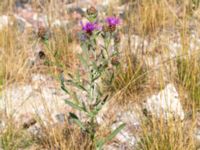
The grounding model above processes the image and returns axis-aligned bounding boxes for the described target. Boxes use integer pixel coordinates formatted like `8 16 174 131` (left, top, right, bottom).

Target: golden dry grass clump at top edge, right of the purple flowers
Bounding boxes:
123 0 175 36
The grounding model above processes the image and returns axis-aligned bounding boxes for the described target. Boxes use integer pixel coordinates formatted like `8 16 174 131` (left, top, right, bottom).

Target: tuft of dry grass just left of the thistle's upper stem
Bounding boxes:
43 27 77 74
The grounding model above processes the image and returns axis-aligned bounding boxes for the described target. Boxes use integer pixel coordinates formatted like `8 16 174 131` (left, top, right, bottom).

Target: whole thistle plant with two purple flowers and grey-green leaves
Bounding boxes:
61 7 125 150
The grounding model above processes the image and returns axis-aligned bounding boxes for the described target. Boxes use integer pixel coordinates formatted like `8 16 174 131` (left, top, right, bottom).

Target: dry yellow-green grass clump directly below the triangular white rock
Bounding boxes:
138 118 195 150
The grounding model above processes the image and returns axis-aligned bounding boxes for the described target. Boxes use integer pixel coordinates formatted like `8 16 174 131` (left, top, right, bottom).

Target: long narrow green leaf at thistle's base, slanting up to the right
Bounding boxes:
96 123 125 150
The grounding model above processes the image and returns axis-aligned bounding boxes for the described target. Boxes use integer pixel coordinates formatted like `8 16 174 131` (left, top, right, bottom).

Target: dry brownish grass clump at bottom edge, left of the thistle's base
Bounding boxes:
35 124 94 150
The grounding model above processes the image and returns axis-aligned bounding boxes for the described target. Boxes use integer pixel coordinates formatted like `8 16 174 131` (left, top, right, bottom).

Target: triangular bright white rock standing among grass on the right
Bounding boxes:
144 84 184 120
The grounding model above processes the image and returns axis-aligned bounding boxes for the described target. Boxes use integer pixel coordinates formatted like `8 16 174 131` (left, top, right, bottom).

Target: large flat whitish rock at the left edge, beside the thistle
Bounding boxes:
0 82 70 123
